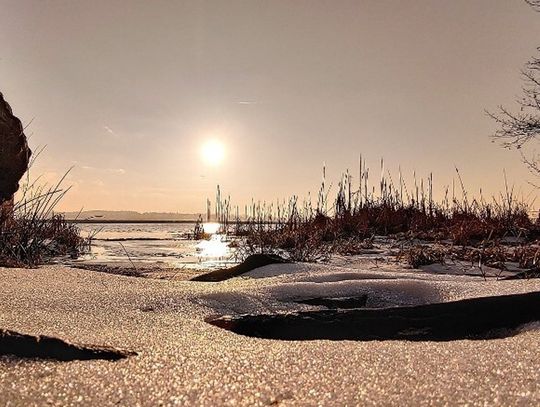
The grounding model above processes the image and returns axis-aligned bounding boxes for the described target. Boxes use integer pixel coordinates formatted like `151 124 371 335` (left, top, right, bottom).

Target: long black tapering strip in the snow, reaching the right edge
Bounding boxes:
208 292 540 341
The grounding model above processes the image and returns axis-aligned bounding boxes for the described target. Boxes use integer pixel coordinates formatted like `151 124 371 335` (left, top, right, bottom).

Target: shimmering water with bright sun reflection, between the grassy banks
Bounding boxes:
78 223 234 270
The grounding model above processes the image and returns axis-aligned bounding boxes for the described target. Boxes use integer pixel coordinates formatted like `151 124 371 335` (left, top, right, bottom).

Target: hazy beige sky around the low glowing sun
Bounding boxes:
0 0 540 213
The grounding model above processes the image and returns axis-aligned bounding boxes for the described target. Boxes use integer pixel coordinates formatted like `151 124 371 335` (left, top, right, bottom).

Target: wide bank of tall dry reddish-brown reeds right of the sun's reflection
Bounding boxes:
208 161 540 264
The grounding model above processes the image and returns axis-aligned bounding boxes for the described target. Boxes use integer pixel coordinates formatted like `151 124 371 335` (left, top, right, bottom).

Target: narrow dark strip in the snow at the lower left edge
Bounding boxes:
0 329 137 361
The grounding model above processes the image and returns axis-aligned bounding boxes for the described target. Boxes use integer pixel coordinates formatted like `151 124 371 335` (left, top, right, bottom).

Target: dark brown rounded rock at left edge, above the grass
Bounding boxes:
0 93 31 207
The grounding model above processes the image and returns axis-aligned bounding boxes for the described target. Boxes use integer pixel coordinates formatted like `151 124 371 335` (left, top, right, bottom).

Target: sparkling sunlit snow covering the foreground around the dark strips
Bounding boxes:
0 264 540 406
